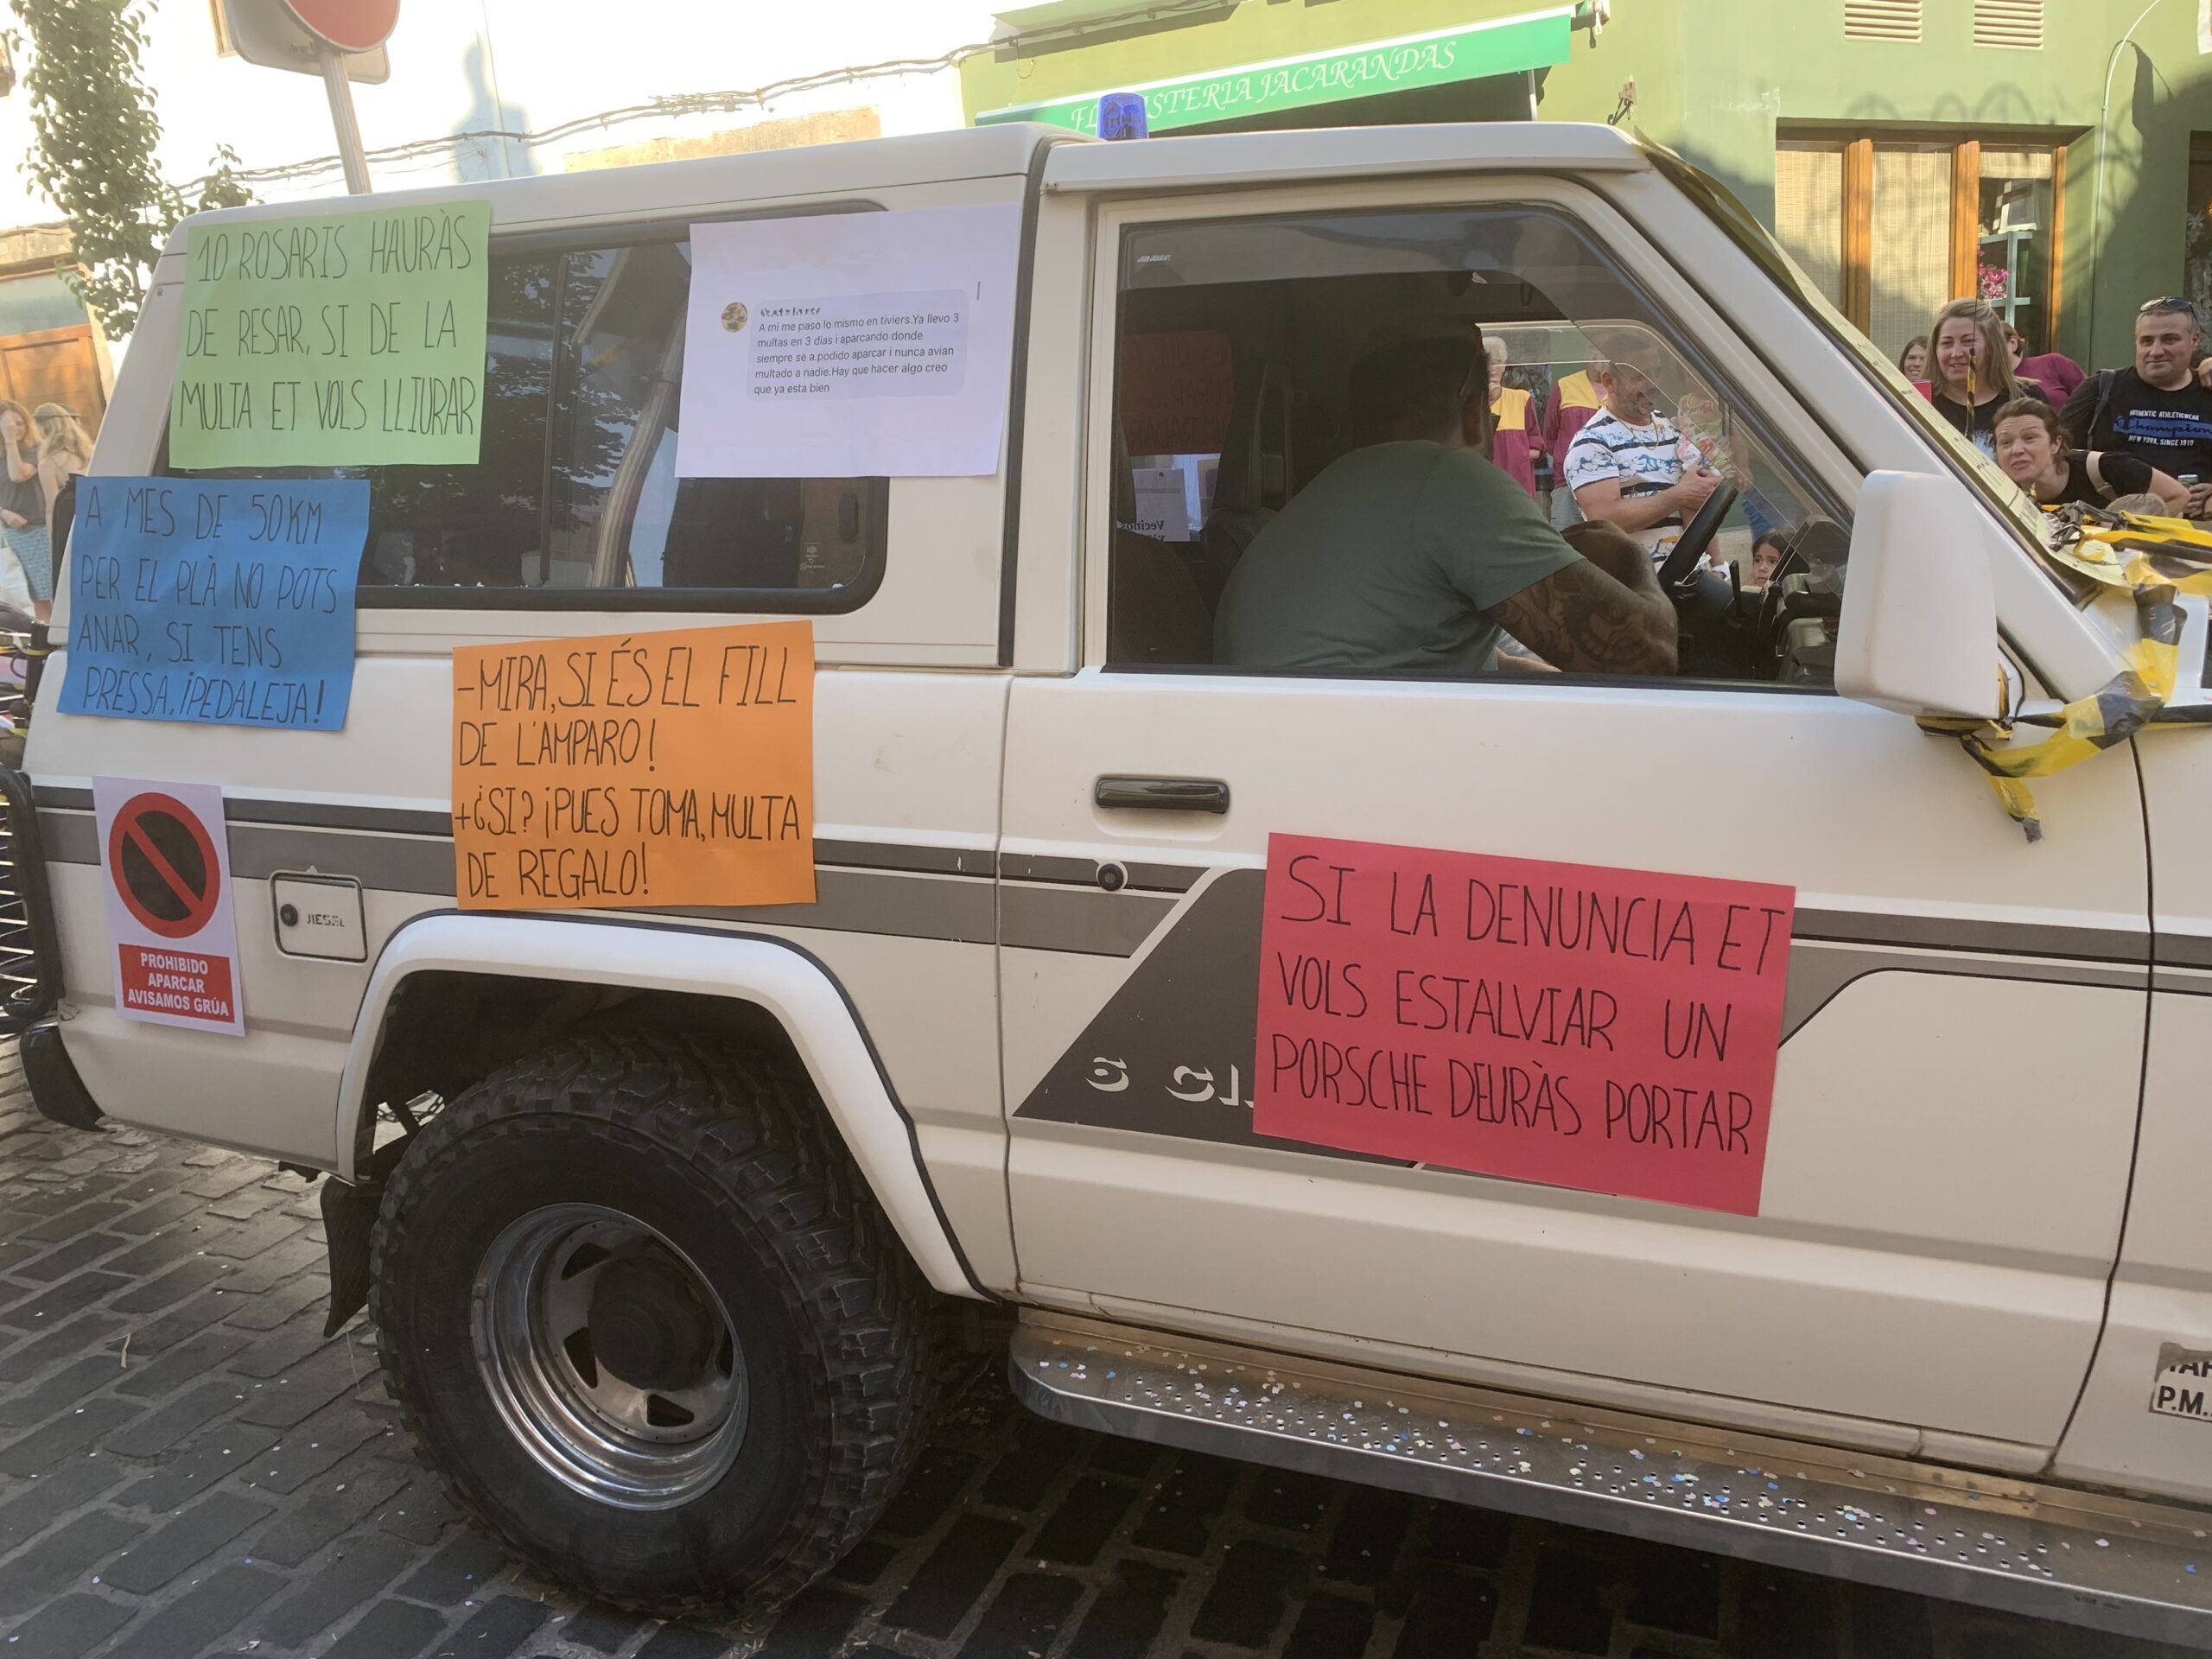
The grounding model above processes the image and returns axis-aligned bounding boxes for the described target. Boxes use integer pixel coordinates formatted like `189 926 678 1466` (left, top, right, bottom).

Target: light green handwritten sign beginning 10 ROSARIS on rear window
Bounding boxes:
168 201 491 469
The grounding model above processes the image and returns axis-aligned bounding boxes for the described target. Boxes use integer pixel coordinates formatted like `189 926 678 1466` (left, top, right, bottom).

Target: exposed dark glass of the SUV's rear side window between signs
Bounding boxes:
166 238 889 611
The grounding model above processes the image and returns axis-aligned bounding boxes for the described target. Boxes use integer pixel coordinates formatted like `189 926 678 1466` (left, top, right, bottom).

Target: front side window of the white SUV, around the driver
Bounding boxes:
1106 206 1849 686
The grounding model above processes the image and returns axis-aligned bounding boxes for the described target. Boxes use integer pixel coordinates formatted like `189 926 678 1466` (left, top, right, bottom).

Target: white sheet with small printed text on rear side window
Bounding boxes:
677 201 1022 478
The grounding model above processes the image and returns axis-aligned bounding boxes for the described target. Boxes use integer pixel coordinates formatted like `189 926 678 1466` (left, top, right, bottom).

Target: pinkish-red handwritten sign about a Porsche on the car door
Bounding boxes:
1252 836 1796 1214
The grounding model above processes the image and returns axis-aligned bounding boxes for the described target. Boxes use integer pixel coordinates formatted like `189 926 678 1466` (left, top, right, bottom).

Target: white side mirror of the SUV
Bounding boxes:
1836 471 1999 719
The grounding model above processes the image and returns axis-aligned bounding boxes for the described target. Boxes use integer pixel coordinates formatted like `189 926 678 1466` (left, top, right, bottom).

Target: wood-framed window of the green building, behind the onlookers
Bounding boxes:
1774 133 2066 356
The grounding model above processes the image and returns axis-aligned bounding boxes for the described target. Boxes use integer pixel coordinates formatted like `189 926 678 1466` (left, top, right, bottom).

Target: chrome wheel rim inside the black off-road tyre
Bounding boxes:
471 1204 746 1509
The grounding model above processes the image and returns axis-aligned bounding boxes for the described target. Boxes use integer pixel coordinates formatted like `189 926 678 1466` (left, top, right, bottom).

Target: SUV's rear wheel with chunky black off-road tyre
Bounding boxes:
370 1031 931 1615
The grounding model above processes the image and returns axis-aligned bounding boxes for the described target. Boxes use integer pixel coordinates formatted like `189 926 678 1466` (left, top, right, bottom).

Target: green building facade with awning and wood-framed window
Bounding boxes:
960 0 2212 363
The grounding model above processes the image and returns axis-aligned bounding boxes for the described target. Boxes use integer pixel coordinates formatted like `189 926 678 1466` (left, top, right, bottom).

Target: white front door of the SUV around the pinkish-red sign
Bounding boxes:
1002 159 2145 1466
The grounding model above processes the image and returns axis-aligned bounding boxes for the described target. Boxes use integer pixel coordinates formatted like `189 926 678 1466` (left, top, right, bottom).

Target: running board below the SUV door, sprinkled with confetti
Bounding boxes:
1008 1312 2212 1650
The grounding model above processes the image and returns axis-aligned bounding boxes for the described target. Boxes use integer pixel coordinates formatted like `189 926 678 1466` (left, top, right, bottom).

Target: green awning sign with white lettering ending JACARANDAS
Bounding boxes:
976 7 1575 133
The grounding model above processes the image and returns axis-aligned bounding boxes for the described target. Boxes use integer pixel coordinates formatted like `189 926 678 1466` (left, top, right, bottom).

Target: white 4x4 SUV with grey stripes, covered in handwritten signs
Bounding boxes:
4 124 2212 1642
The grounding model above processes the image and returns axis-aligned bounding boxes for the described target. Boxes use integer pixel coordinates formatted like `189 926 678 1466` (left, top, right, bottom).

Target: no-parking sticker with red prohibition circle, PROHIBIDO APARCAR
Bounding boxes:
93 779 245 1038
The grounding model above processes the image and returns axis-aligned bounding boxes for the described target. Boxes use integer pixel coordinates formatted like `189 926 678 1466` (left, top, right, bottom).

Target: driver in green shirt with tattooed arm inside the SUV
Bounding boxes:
1214 332 1675 677
